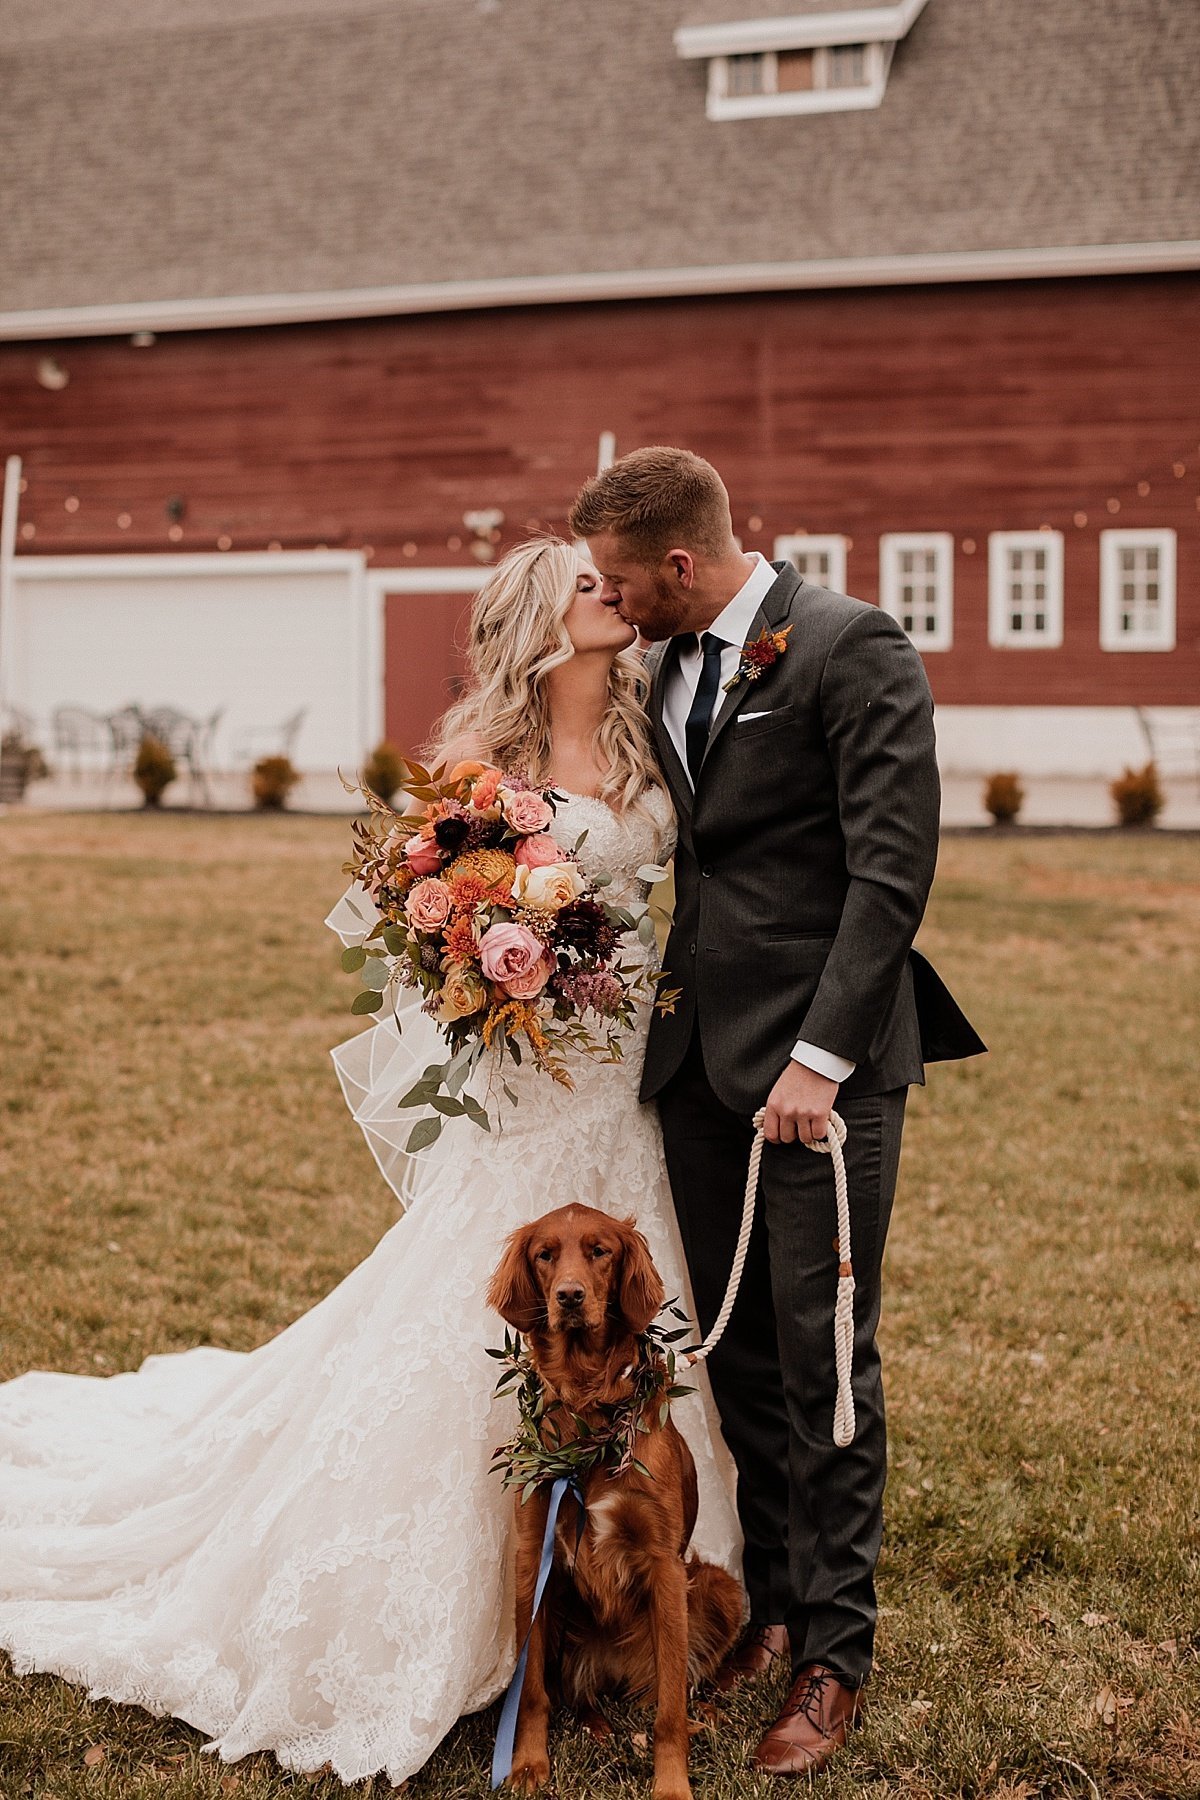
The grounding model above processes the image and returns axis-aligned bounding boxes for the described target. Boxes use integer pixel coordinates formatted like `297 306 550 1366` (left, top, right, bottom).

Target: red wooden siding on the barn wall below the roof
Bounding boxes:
0 275 1200 706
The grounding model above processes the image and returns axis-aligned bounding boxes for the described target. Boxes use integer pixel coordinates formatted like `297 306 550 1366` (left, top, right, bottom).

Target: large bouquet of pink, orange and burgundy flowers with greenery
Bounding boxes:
342 761 675 1150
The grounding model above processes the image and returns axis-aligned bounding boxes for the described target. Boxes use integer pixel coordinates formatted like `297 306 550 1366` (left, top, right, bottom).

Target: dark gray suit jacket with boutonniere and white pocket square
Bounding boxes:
642 563 984 1114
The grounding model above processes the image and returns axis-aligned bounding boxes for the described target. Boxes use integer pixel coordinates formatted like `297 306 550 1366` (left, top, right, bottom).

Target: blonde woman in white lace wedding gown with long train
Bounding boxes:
0 542 739 1782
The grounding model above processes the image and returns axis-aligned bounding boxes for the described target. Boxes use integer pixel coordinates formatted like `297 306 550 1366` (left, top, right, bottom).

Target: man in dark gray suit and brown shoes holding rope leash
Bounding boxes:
570 448 984 1775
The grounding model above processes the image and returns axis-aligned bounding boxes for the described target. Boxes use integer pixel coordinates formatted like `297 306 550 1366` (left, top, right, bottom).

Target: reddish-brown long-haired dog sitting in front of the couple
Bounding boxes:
488 1206 741 1800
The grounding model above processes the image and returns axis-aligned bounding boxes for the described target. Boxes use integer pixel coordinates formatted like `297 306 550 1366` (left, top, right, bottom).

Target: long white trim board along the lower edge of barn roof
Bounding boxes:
0 238 1200 340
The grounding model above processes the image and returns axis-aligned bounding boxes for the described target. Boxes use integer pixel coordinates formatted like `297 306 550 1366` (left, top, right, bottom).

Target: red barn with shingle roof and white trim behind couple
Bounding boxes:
0 0 1200 788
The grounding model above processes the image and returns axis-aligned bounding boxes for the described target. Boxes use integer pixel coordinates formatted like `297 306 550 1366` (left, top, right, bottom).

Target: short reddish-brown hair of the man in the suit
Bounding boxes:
570 445 732 567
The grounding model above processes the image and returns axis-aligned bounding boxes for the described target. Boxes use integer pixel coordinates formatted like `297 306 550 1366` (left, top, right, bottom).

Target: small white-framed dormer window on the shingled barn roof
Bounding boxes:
675 0 927 119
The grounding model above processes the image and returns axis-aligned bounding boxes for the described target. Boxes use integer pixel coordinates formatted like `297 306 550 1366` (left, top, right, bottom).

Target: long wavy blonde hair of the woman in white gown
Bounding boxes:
428 538 662 812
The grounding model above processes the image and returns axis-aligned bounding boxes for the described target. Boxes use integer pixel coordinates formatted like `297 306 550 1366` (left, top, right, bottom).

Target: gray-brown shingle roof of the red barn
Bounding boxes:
0 0 1200 329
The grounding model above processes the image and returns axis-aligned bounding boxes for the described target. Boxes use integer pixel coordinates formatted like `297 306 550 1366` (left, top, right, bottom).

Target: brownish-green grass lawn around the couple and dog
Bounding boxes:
0 814 1200 1800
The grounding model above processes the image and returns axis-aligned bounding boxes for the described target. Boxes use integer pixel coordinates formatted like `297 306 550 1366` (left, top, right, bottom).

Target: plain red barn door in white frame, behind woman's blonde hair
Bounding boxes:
383 594 473 756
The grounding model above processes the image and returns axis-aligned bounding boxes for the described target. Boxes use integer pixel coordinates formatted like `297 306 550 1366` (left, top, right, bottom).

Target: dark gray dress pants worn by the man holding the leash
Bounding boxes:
658 1030 909 1688
